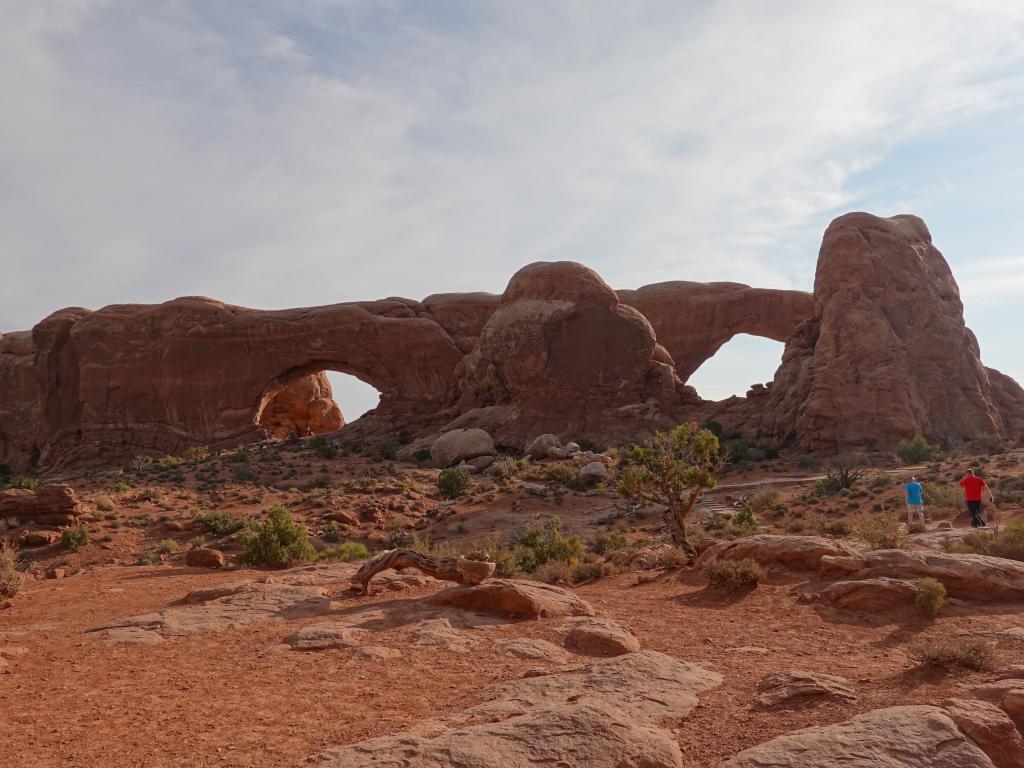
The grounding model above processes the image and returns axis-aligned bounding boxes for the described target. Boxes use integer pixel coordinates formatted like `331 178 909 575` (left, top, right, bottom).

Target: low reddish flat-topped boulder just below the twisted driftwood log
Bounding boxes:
429 579 594 618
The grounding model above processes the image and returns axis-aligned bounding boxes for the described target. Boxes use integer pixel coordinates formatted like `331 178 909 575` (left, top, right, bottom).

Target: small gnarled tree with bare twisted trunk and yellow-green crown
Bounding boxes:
618 422 725 555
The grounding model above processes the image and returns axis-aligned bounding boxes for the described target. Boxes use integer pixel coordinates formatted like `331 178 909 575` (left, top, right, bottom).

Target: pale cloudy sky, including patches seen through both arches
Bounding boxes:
0 0 1024 417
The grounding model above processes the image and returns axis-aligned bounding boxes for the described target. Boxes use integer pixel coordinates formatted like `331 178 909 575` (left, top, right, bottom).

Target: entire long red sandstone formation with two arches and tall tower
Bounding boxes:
0 213 1024 471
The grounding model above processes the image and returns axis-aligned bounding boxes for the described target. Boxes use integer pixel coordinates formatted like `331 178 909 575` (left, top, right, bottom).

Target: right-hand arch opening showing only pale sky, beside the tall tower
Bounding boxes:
686 334 785 400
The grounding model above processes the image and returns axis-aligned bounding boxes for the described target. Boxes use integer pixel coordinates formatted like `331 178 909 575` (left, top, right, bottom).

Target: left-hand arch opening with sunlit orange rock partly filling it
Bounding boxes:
253 364 380 439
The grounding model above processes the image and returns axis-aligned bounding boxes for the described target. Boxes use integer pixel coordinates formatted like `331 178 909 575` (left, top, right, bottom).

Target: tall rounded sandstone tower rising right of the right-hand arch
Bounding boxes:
744 213 1024 453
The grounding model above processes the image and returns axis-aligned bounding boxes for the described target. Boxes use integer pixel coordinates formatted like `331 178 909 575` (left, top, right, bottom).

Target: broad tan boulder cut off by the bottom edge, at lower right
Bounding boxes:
721 706 998 768
